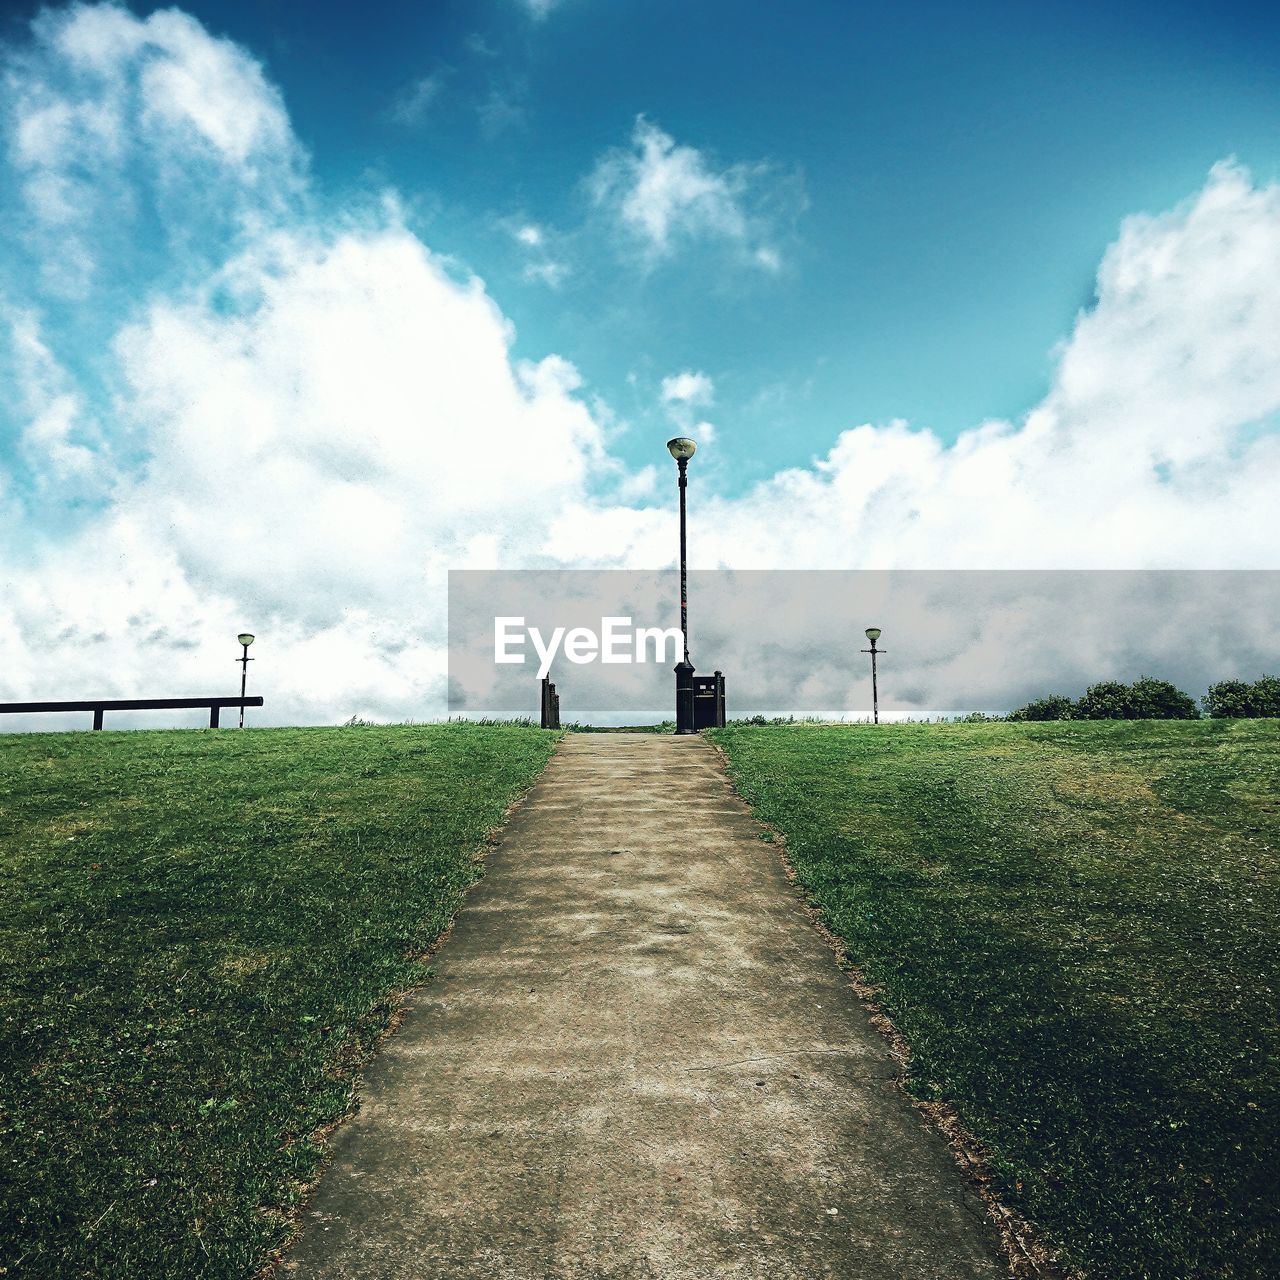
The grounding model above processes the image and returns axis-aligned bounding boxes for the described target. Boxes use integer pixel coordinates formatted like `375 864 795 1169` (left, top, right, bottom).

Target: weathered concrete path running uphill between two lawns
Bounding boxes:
285 733 1005 1280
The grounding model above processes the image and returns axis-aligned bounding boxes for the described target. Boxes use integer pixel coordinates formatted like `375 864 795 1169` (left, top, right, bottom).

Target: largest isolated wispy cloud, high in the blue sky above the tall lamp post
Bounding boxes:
588 115 782 273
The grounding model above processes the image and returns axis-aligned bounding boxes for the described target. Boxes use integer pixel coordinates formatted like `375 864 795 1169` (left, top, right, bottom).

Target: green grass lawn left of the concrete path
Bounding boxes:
0 724 556 1280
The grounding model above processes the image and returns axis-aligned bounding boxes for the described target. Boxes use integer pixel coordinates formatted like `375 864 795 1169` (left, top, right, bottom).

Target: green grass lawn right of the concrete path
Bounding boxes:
716 721 1280 1280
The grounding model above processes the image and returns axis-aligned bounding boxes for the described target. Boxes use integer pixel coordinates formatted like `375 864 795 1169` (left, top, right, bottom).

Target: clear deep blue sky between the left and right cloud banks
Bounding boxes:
7 0 1280 490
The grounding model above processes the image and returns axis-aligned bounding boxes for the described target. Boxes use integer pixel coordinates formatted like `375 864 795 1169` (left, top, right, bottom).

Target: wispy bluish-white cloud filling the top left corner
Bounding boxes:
0 5 305 300
